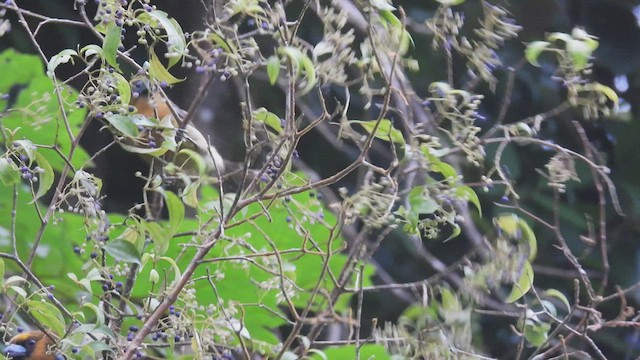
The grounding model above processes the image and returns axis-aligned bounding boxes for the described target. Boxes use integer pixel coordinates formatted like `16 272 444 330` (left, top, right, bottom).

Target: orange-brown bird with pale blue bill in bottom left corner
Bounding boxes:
2 330 63 360
